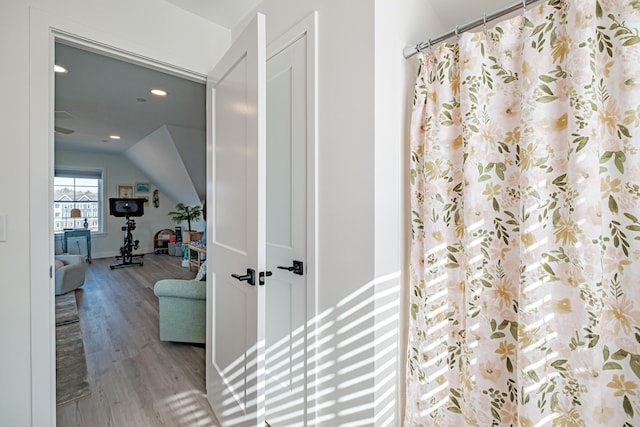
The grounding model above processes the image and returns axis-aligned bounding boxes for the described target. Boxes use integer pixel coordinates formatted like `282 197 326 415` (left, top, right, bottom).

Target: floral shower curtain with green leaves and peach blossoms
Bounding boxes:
405 0 640 427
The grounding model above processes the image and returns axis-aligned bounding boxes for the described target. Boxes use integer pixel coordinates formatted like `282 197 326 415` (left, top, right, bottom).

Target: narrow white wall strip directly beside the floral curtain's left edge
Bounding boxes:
374 0 443 425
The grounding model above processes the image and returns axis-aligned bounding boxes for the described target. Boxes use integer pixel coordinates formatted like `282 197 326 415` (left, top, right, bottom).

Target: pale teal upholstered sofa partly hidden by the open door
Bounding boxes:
153 279 207 344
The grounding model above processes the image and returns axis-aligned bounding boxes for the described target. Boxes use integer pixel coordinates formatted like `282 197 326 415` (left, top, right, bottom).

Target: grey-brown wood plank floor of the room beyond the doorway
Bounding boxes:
57 254 219 427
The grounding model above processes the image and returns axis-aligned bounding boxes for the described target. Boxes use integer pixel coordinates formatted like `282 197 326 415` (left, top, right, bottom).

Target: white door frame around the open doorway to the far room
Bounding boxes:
29 8 206 426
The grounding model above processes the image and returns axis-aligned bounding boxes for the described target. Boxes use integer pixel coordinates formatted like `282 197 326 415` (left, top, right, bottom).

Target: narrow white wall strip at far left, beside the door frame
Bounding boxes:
0 1 31 426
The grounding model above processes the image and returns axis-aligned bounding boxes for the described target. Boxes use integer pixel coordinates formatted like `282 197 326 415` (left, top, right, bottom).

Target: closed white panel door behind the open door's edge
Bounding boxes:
265 37 307 427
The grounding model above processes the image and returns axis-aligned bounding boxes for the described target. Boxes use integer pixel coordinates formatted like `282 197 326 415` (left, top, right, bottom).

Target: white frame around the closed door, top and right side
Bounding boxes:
266 12 320 425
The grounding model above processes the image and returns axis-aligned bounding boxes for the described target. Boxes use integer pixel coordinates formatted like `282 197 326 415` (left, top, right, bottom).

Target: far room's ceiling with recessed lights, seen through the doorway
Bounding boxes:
55 43 206 153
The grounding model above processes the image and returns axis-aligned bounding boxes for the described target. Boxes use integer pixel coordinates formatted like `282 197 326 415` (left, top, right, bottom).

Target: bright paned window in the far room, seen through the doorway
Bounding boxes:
53 168 103 233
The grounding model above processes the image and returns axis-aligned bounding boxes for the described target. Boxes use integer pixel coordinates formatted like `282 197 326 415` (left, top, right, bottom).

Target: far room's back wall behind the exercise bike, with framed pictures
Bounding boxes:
55 150 182 258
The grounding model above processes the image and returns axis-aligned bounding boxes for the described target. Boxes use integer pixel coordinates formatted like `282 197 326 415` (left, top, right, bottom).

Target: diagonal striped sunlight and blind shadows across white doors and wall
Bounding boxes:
211 274 401 427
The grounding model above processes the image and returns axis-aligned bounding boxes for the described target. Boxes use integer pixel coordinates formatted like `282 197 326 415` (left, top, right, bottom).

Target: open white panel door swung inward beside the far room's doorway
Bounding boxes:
206 14 266 427
